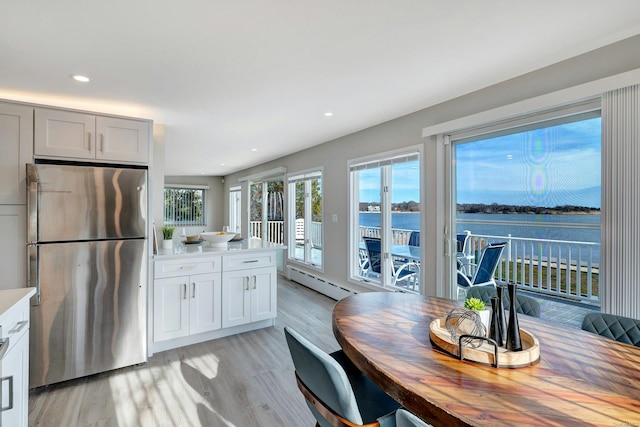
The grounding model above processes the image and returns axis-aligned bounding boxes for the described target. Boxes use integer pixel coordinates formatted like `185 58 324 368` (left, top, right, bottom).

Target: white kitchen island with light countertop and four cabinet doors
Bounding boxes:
150 239 286 352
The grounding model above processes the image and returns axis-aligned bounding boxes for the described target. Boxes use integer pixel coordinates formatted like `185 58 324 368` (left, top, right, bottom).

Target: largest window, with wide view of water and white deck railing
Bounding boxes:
451 102 601 302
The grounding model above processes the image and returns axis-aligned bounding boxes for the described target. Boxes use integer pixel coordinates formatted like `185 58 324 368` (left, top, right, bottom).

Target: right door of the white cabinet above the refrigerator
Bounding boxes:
96 116 149 164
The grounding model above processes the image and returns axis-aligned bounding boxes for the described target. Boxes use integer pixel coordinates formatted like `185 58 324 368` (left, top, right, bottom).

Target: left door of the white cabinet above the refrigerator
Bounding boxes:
33 108 96 159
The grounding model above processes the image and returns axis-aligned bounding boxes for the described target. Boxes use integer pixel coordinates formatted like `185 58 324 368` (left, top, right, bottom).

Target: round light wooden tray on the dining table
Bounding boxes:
429 318 540 368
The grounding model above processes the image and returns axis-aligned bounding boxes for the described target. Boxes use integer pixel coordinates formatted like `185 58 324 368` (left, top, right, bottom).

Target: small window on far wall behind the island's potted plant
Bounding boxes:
164 185 207 226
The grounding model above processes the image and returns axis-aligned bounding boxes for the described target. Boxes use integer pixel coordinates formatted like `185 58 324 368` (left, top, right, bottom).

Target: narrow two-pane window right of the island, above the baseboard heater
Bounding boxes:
287 171 323 268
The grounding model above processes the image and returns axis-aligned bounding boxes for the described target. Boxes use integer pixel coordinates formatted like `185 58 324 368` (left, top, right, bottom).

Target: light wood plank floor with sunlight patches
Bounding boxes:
29 278 339 427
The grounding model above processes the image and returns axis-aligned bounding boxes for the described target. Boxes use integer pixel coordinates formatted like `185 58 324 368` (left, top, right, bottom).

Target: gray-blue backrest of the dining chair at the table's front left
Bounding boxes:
284 327 362 424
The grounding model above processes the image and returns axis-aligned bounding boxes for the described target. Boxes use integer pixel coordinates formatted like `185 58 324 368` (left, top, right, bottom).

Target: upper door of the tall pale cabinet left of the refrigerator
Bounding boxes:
0 103 33 205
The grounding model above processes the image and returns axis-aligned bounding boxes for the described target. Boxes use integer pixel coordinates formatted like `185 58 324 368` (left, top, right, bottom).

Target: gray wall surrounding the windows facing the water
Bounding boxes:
224 36 640 295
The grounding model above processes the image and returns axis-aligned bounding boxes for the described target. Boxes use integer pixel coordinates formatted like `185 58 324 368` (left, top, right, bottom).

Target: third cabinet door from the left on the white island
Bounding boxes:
222 270 251 328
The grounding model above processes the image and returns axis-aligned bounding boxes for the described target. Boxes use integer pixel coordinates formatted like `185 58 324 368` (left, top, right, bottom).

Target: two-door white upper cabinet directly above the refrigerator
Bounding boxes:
34 108 149 164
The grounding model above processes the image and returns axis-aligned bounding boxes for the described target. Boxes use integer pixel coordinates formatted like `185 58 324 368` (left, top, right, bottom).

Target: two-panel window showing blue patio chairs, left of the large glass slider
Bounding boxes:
349 150 421 292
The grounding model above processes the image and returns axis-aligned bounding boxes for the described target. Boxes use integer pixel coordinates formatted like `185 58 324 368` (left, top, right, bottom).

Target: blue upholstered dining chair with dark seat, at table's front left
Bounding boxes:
284 327 400 427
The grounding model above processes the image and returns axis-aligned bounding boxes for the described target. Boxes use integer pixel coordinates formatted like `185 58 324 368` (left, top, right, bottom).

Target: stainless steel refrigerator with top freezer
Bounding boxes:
27 164 147 387
